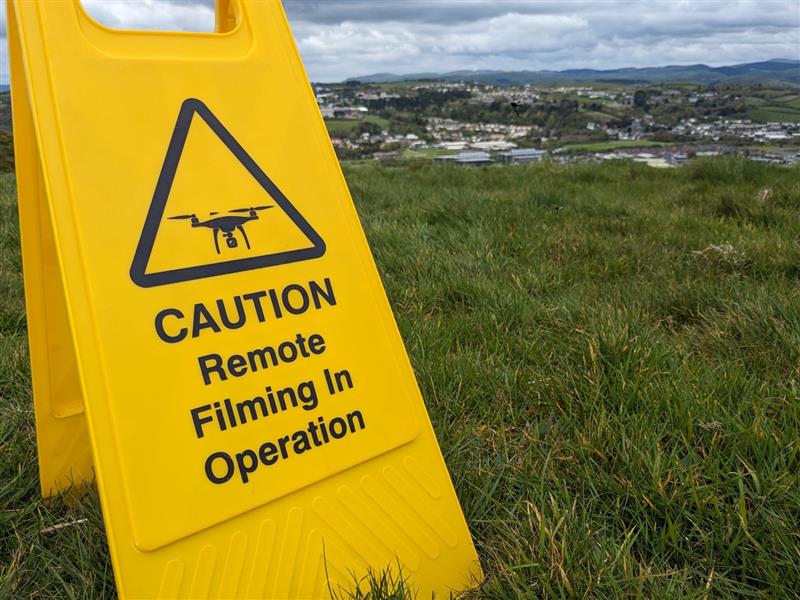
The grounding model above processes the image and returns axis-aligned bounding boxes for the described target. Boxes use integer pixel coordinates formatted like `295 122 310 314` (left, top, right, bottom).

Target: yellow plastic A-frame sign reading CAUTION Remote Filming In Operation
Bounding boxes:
7 0 480 598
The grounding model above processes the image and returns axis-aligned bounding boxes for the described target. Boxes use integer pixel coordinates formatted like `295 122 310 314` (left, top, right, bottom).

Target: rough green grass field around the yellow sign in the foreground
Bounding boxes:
0 159 800 600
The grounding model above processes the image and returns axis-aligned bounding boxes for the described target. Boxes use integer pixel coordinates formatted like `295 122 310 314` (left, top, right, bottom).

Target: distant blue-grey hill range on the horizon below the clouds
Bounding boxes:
347 59 800 86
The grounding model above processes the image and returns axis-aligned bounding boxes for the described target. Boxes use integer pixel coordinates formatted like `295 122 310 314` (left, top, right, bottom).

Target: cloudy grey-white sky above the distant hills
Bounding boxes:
0 0 800 84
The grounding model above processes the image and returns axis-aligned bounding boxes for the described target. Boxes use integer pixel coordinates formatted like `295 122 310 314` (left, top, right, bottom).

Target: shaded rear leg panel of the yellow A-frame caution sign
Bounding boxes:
8 2 94 496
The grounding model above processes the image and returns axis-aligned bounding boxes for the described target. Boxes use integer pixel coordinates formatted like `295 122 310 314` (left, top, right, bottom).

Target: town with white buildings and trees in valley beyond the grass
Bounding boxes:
313 80 800 167
